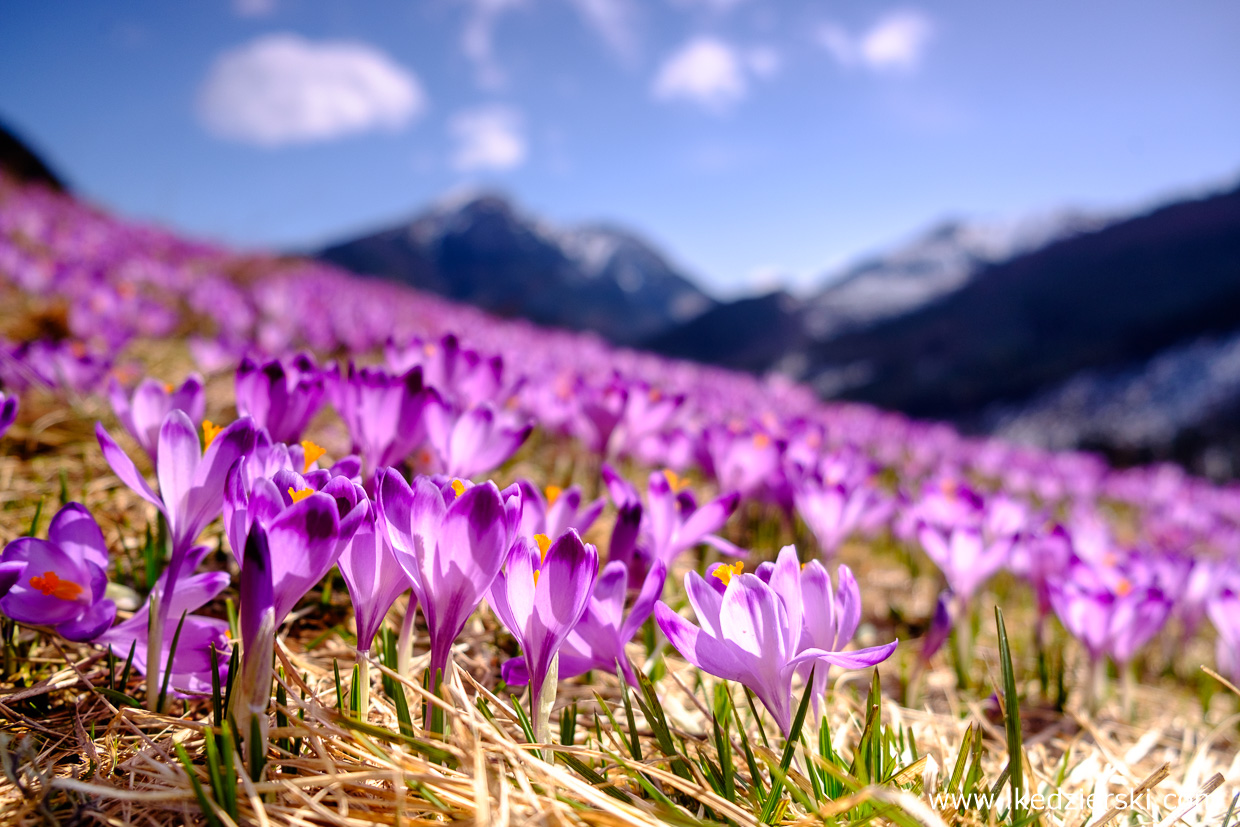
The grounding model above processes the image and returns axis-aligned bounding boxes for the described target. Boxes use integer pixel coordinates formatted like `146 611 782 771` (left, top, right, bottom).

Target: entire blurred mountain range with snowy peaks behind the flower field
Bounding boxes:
320 181 1240 477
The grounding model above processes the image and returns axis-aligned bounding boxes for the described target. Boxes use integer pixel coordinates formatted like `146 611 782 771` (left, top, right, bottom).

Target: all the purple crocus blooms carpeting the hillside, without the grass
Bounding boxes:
0 164 1240 738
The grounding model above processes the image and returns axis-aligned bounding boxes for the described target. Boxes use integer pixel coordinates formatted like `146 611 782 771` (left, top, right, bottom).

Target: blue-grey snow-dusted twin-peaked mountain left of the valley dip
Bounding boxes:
317 195 714 345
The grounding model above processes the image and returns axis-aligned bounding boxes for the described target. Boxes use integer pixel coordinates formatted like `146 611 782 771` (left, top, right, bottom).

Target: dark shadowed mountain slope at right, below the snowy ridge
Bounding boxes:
805 183 1240 420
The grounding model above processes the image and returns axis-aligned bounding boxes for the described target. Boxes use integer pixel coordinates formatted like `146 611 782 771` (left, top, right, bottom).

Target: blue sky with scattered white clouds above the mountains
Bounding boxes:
0 0 1240 295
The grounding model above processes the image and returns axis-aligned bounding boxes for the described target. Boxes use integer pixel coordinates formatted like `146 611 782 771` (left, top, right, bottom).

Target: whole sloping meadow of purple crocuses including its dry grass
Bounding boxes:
0 169 1240 826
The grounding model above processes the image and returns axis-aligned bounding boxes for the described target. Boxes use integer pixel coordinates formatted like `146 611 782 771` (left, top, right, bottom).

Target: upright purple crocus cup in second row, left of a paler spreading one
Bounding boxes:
330 363 429 485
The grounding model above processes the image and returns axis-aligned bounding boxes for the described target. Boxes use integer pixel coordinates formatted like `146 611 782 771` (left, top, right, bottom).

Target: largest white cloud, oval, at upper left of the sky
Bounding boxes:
198 33 427 146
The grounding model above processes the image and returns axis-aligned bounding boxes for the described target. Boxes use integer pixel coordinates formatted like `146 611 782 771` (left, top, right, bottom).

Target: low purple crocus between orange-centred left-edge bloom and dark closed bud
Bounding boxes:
94 546 231 705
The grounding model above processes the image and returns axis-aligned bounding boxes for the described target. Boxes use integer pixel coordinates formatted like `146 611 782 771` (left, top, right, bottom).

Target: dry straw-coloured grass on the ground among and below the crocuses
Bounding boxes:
0 348 1240 827
